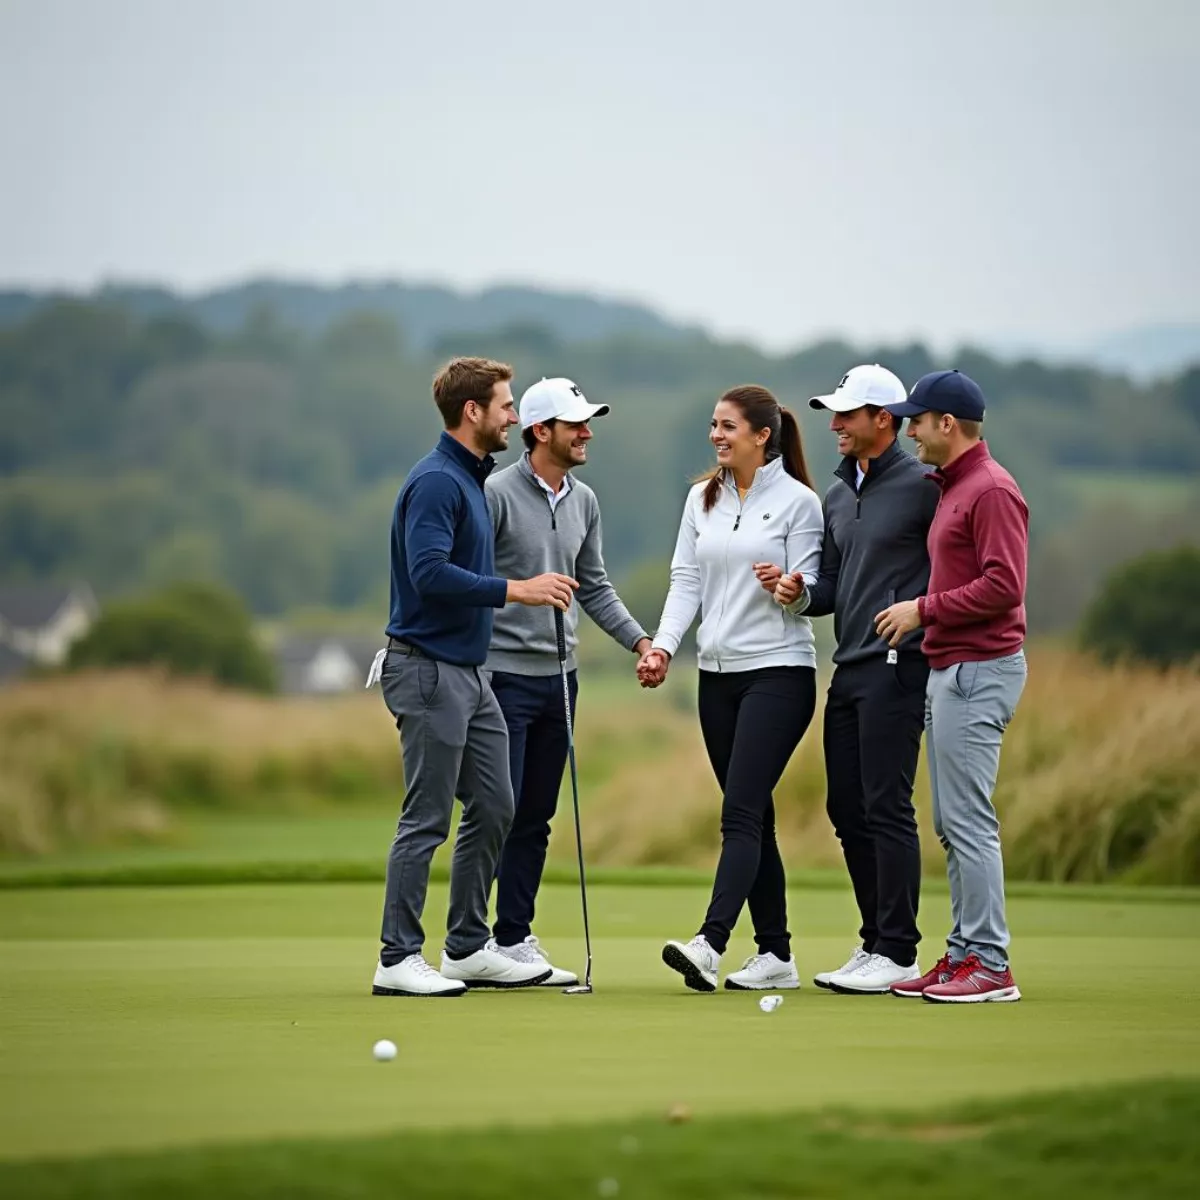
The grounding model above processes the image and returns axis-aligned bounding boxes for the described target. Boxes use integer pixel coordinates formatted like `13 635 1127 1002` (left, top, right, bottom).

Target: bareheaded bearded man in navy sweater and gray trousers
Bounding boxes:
367 359 576 996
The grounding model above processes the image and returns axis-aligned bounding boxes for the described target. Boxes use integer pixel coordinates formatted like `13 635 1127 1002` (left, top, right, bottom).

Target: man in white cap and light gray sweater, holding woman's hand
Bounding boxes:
486 379 650 986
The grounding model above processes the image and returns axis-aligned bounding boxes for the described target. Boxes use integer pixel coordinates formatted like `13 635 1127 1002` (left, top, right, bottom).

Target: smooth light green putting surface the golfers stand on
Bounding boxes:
0 883 1200 1171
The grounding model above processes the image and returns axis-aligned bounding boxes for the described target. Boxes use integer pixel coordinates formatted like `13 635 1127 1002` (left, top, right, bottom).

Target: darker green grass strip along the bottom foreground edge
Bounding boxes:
0 1081 1200 1200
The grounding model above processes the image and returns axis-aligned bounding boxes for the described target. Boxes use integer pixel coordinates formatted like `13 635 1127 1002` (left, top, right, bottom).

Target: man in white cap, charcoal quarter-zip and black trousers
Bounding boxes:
776 365 938 995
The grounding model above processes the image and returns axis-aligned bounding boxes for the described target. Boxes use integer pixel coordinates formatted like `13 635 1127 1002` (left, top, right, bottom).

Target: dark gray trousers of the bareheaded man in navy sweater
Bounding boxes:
379 650 512 966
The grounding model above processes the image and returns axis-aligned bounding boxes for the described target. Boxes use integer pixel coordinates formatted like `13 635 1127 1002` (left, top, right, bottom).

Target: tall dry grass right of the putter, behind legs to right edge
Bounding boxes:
556 647 1200 883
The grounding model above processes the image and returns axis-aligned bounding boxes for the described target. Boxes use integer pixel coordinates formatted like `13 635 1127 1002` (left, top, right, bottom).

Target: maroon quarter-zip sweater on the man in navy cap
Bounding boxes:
917 442 1030 670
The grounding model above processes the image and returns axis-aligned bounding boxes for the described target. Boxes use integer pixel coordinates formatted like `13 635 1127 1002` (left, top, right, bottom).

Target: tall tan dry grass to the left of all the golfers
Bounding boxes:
0 672 401 854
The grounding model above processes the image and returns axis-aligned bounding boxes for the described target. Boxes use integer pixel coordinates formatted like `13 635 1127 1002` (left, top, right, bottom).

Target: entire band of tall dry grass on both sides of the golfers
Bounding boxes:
7 647 1200 883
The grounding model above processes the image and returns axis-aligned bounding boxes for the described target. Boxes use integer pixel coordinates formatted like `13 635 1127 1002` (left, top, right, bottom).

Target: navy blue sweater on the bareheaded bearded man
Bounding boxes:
388 433 508 667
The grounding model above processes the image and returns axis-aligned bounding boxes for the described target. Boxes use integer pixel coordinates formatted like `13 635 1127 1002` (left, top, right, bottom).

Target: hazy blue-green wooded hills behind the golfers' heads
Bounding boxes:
0 292 1200 629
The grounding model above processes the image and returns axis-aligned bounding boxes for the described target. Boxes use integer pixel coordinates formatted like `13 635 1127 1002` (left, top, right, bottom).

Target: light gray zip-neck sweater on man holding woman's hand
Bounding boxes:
486 454 647 676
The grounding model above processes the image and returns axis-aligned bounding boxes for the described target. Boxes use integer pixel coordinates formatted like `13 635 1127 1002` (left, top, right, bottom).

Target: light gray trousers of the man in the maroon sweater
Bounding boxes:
925 650 1026 971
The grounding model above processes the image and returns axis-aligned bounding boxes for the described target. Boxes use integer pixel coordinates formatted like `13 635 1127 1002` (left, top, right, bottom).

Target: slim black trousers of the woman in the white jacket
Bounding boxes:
700 667 816 960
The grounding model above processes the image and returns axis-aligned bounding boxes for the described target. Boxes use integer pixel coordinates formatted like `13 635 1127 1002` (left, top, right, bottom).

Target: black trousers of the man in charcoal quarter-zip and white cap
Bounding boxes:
824 654 929 966
